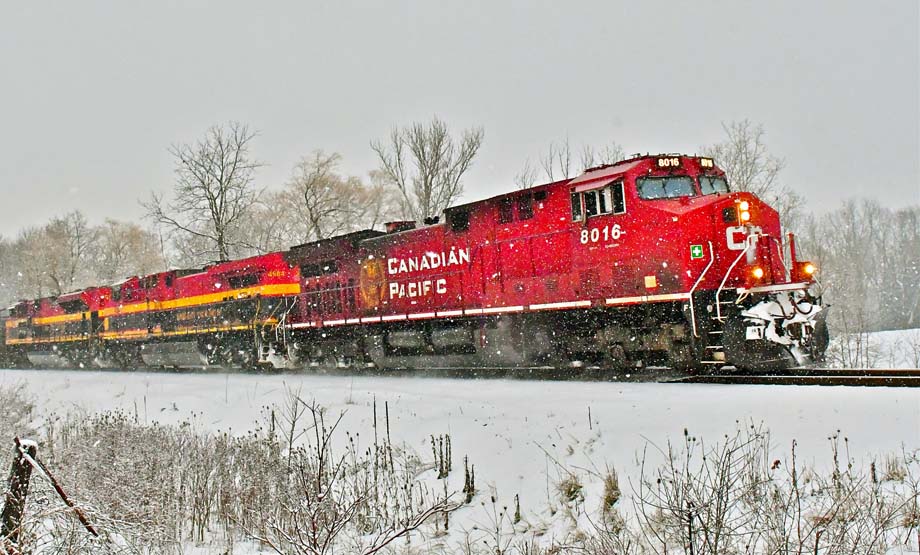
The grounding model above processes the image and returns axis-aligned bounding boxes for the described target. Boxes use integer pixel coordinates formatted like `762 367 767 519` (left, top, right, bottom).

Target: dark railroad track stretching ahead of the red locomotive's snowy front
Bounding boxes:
667 368 920 387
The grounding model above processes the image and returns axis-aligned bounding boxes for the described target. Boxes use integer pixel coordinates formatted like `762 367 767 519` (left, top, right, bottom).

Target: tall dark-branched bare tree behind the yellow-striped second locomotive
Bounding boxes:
142 122 261 260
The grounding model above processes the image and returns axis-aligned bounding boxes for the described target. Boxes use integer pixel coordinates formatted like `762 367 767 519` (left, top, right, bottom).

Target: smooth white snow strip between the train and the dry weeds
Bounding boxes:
0 364 920 552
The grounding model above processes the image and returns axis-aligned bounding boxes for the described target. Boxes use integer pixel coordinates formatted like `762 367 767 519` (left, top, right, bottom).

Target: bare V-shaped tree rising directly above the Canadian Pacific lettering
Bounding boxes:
371 117 484 221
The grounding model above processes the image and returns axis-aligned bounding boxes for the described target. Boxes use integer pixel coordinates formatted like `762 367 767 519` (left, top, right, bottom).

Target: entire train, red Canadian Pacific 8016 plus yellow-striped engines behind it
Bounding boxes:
5 155 828 370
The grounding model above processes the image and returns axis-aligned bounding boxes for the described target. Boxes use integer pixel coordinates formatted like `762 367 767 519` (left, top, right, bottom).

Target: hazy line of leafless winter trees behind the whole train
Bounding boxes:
0 117 920 346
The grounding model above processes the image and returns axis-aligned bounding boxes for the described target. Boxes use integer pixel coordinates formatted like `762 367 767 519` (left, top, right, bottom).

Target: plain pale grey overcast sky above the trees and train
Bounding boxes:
0 0 920 236
